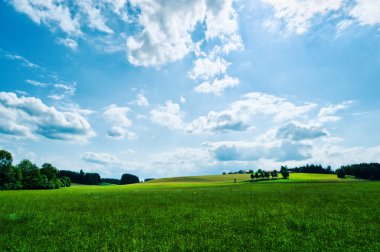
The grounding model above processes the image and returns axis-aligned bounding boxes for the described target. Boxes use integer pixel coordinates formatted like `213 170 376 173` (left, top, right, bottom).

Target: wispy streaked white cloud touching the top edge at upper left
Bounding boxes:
11 0 81 35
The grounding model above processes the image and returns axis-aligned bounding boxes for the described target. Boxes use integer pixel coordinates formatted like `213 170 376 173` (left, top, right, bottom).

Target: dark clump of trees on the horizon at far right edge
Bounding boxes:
336 163 380 180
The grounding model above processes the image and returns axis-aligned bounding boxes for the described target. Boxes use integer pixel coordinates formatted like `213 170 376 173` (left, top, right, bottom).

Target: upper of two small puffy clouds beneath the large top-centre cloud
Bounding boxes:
188 57 230 80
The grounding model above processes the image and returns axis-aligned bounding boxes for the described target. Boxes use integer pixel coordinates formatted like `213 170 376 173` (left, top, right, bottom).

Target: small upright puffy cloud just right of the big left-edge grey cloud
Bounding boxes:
103 104 136 139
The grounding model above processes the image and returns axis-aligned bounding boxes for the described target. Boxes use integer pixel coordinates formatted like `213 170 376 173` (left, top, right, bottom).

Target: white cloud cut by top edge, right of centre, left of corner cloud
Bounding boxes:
262 0 343 34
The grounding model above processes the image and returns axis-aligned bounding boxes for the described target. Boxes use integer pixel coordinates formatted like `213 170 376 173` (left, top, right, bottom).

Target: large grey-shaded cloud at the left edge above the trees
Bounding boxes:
0 92 95 141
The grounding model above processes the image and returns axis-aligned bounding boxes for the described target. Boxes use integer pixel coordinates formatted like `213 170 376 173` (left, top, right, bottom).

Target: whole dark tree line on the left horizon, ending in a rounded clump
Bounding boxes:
0 150 140 190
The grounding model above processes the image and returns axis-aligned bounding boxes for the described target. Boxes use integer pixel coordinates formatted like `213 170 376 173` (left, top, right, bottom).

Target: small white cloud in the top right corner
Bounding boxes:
349 0 380 25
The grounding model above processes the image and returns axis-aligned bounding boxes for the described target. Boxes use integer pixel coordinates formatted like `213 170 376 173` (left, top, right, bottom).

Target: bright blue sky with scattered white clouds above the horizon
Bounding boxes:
0 0 380 179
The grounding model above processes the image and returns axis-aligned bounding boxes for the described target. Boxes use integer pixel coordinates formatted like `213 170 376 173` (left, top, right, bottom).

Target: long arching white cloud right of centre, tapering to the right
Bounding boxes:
187 92 316 133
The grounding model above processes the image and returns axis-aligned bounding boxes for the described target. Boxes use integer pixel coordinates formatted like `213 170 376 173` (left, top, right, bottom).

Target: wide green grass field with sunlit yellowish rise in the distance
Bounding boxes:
0 174 380 251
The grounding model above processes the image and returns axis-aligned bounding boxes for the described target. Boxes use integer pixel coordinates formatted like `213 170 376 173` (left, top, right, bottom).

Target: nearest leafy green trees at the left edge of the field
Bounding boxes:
0 150 71 190
